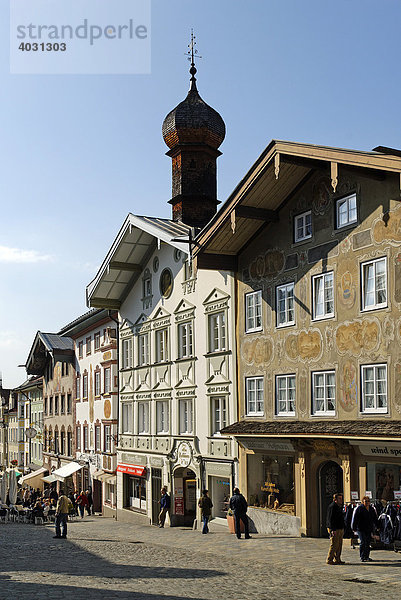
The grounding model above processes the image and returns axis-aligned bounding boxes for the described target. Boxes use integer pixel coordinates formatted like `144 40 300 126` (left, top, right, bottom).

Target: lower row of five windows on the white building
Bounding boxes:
121 396 228 435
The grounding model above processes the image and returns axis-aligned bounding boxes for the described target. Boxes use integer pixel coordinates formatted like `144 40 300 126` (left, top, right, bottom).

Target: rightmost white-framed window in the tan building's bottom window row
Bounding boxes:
361 364 387 413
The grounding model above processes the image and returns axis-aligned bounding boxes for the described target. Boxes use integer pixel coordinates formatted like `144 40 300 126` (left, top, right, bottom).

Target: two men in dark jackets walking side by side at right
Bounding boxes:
326 493 379 565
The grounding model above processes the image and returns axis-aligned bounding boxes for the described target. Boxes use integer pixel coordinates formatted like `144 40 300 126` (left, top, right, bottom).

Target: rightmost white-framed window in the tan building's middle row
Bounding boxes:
361 257 387 310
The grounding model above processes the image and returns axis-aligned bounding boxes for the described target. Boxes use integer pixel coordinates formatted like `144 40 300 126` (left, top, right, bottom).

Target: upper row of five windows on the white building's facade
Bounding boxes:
121 311 227 369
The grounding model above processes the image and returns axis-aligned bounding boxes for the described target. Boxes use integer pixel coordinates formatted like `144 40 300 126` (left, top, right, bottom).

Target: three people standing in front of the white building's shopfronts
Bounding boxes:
158 486 251 539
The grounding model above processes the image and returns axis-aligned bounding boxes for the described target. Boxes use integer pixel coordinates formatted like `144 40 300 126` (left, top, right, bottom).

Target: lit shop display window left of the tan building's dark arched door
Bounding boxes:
248 454 295 513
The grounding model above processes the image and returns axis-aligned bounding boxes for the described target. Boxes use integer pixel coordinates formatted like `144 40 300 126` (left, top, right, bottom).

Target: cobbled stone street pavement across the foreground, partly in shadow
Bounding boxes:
0 516 401 600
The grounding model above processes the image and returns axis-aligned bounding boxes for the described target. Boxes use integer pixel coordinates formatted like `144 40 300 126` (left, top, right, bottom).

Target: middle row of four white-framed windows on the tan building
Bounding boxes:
245 257 387 333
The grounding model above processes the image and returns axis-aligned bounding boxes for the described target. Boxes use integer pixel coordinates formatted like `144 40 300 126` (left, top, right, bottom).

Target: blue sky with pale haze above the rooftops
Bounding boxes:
0 0 401 387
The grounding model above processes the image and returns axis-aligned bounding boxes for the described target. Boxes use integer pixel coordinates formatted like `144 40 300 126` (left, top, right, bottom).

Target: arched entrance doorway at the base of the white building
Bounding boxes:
172 467 196 527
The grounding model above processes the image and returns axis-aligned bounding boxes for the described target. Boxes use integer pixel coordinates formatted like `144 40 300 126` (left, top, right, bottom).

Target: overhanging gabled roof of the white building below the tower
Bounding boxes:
86 213 191 309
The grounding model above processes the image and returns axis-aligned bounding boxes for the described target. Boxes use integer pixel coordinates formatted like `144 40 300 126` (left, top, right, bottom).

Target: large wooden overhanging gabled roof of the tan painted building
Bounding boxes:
194 140 401 269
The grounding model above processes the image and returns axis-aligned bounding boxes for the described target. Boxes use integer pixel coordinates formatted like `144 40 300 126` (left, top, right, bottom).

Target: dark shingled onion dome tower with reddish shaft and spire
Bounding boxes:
162 34 226 227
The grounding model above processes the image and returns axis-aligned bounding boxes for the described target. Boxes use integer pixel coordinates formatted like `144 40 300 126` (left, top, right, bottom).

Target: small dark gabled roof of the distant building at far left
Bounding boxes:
25 331 74 375
